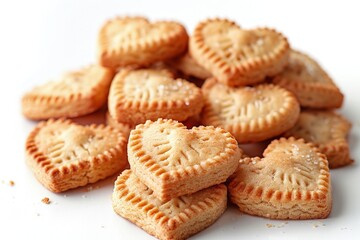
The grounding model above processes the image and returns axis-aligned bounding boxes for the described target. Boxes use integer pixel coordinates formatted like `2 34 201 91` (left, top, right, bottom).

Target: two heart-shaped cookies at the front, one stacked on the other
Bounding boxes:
113 119 241 239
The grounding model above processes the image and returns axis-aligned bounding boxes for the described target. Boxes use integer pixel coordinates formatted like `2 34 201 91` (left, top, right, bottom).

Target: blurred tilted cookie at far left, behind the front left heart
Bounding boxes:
22 65 114 120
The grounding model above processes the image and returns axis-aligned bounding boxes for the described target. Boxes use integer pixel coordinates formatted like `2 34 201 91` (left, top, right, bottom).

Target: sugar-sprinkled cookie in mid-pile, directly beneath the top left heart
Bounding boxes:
109 69 203 125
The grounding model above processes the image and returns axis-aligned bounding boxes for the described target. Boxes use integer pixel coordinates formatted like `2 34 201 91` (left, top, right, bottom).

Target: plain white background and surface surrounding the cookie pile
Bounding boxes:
0 0 360 239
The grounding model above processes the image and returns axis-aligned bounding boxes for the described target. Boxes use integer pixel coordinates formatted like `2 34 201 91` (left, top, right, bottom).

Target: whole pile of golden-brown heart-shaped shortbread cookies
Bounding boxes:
22 17 352 239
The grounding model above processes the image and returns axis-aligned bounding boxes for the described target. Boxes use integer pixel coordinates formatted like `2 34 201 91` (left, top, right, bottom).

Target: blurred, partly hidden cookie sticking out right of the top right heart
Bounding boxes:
273 50 344 108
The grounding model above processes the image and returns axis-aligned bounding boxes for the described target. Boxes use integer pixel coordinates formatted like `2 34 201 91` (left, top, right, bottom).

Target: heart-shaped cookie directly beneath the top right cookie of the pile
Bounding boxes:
202 79 300 143
